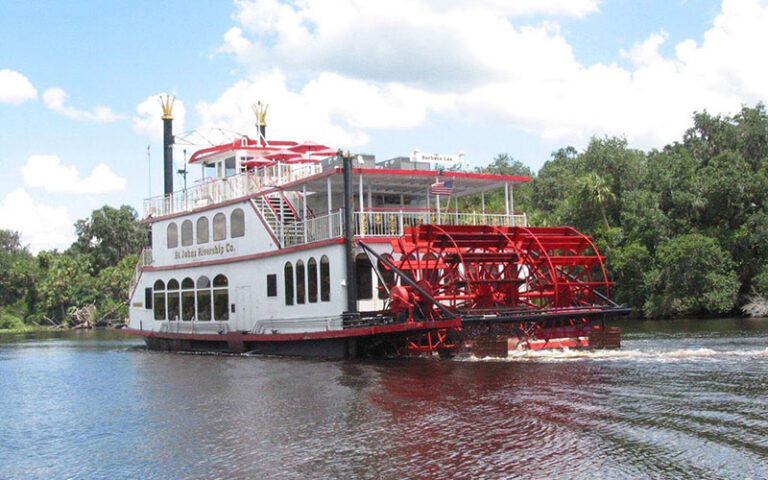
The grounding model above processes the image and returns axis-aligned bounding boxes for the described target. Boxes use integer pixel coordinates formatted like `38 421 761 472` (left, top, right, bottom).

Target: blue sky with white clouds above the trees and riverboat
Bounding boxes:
0 0 768 252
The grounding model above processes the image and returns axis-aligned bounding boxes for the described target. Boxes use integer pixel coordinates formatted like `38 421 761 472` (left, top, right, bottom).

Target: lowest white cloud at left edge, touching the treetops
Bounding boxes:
0 188 75 253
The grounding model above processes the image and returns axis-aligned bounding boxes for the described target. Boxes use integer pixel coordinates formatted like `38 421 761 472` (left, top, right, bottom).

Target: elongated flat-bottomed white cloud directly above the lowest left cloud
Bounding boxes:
21 155 127 194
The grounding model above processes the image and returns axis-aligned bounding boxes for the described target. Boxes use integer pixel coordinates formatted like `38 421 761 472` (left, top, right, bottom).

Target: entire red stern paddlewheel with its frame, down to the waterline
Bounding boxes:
359 224 629 355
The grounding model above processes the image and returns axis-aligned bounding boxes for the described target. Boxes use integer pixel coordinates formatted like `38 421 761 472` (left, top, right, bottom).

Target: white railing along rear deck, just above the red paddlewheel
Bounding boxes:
355 211 528 237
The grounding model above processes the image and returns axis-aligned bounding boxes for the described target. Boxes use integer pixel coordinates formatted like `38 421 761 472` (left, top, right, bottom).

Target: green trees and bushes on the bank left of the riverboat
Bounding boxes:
0 205 147 331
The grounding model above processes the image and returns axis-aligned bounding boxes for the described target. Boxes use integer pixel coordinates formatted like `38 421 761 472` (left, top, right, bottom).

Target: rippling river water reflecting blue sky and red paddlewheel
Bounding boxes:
0 319 768 479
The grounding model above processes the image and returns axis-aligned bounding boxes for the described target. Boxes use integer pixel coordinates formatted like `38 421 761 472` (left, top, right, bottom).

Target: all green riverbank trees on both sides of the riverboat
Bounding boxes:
0 104 768 329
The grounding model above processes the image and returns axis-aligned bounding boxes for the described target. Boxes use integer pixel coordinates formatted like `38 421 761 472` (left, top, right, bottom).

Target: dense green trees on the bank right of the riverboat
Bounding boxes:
468 104 768 318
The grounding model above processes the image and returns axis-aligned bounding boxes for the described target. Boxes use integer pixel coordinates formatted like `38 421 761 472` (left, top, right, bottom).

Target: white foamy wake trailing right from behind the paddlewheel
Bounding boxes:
459 347 768 362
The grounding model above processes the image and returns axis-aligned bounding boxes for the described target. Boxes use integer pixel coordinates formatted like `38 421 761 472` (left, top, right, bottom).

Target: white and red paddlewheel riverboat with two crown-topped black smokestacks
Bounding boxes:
124 97 629 358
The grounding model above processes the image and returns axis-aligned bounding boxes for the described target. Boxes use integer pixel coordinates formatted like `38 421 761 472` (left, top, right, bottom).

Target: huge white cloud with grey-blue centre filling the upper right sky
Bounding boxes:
208 0 768 152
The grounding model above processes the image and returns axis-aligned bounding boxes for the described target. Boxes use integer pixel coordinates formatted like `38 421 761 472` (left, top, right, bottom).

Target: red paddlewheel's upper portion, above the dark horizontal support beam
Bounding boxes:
384 225 610 320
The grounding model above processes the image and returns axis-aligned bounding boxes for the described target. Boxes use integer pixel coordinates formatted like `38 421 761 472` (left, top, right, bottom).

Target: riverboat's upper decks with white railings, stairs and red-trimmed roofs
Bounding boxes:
142 137 529 248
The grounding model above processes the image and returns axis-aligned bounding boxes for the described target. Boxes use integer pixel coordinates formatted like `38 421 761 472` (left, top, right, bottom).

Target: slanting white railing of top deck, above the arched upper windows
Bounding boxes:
142 164 322 218
